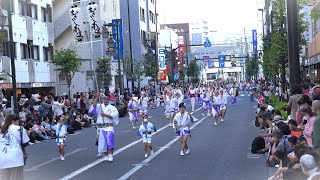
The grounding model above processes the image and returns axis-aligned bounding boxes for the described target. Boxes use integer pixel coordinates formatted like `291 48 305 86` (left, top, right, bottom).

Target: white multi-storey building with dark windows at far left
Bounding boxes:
0 0 55 96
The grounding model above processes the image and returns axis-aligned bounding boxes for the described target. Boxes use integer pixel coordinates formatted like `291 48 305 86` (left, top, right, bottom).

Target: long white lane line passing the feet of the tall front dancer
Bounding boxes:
60 108 201 180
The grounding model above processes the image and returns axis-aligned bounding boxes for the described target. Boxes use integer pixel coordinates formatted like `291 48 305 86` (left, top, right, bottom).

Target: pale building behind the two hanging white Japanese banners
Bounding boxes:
53 0 123 94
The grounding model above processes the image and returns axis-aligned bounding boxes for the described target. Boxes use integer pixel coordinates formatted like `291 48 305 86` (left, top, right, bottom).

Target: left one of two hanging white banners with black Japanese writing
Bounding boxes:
69 5 85 41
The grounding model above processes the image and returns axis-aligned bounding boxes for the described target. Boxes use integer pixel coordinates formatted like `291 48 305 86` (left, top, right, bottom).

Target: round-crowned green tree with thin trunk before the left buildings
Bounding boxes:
51 49 81 98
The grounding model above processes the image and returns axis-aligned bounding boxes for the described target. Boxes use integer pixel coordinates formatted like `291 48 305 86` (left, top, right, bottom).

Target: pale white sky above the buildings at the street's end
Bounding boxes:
157 0 262 34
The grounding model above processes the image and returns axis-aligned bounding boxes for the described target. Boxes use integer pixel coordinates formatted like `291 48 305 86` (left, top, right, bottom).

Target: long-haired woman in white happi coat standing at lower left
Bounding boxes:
0 114 29 180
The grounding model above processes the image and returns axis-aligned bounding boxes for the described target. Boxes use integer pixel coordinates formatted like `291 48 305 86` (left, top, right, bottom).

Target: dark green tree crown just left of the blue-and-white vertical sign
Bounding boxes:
143 54 159 79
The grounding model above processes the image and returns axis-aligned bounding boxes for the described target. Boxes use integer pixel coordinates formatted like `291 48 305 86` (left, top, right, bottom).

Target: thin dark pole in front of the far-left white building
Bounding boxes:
7 0 19 115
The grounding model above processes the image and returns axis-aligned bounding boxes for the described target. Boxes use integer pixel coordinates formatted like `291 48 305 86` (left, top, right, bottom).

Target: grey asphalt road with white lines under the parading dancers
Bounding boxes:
25 93 269 180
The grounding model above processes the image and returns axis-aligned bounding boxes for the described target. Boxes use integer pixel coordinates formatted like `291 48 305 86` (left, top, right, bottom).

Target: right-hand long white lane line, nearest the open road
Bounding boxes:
118 117 206 180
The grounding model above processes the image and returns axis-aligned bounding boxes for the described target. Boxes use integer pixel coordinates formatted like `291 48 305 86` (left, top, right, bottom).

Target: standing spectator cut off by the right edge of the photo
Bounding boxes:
312 100 320 153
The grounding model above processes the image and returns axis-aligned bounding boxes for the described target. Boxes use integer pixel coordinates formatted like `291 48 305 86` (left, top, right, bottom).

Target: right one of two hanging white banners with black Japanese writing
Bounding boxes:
87 3 101 37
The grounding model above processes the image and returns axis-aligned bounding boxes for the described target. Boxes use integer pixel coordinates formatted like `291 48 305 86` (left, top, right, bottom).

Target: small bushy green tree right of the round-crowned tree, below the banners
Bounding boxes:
96 57 112 87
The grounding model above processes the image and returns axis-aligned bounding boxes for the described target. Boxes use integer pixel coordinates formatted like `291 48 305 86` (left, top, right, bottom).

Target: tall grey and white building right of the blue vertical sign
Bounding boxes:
120 0 158 88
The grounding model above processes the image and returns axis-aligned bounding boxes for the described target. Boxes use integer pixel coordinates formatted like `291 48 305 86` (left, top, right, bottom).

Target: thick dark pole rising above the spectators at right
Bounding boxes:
287 0 301 89
